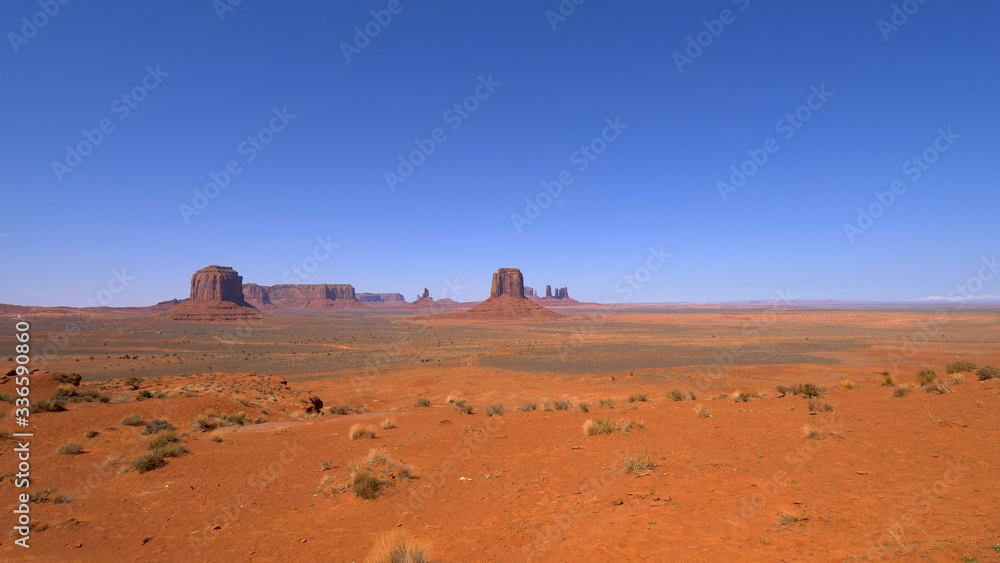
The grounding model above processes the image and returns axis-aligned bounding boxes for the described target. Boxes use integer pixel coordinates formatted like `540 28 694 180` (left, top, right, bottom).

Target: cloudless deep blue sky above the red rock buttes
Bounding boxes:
0 0 1000 305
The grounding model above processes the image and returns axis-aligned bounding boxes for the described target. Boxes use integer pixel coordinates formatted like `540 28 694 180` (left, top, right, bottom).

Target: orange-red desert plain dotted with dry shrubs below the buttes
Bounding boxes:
0 304 1000 562
